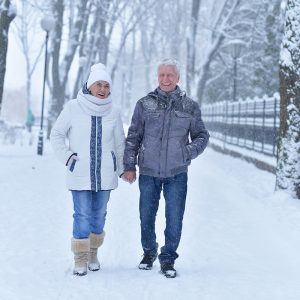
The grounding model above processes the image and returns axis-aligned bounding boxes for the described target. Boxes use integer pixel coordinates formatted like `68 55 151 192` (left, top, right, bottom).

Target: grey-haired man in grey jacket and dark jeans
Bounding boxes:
124 59 209 278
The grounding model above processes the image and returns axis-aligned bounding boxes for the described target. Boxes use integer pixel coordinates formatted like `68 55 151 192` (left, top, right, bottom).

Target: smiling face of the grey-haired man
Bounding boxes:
157 65 179 93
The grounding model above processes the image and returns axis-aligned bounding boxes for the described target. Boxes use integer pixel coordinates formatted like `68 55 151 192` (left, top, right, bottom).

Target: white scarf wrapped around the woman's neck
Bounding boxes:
77 90 112 117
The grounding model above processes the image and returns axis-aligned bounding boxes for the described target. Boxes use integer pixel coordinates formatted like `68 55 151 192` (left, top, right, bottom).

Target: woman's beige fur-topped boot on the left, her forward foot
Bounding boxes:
71 238 90 276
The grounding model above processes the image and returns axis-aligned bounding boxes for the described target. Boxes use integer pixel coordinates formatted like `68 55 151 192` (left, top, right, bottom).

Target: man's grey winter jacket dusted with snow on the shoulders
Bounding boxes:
124 86 209 178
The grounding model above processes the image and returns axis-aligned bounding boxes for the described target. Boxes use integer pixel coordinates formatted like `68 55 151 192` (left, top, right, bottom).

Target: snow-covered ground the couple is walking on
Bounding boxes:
0 134 300 300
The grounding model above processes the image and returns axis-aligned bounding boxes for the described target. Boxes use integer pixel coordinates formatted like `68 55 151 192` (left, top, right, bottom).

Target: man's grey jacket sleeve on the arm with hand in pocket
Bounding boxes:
186 102 209 160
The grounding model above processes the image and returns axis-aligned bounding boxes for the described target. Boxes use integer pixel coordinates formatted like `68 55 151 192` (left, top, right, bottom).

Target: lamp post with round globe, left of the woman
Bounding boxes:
37 16 55 155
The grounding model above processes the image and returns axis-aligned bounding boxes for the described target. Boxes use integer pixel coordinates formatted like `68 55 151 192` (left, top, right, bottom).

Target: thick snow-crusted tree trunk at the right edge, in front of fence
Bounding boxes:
276 0 300 199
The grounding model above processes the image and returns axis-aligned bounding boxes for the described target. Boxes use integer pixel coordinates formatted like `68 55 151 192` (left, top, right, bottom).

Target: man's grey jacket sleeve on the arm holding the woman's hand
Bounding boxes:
124 101 144 171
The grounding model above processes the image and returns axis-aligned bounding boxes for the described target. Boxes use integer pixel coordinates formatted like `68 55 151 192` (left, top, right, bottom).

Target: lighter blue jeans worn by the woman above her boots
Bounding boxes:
71 191 110 239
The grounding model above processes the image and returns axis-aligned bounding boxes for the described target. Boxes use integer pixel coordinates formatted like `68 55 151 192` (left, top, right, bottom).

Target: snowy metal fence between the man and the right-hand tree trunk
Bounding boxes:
201 93 280 156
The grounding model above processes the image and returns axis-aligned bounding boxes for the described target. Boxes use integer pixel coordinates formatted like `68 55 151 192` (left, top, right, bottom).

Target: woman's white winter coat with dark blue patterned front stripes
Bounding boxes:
50 99 125 191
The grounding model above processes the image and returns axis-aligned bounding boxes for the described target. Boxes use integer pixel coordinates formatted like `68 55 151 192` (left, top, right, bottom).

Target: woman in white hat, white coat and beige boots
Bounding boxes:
50 63 125 276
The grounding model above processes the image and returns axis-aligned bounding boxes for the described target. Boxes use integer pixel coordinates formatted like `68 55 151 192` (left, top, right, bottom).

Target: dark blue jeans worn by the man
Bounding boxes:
139 173 187 264
